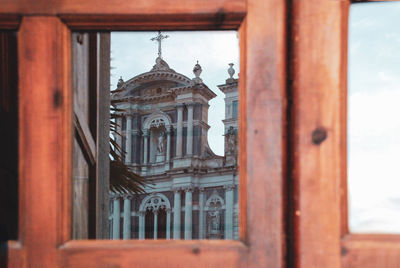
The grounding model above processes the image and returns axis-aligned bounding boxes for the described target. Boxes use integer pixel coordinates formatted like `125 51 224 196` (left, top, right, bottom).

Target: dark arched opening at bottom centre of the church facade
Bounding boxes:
139 193 171 239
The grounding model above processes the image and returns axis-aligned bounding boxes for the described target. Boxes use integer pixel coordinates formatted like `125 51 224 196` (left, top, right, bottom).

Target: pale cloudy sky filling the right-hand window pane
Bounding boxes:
348 2 400 233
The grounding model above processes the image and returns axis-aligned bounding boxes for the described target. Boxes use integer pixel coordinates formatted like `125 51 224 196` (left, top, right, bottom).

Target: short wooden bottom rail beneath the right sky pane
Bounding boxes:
342 234 400 268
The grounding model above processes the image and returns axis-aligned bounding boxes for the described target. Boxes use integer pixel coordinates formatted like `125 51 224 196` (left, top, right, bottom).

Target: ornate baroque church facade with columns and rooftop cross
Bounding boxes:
109 32 239 240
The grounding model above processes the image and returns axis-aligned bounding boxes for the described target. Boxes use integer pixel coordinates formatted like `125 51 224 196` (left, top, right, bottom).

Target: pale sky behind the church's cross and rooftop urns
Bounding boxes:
111 31 239 155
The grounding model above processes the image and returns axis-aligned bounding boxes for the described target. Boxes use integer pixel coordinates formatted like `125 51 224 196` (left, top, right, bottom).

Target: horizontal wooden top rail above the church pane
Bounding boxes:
0 0 246 30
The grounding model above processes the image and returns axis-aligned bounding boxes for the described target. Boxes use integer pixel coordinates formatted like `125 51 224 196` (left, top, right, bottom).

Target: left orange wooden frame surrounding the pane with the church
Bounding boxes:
0 0 286 267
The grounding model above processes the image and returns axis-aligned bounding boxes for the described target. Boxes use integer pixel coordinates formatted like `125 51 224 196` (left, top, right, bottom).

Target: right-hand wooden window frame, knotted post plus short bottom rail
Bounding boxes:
288 0 400 268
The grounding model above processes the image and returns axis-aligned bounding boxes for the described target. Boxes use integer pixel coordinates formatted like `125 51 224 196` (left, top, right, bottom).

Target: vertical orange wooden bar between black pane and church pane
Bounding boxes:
17 17 72 267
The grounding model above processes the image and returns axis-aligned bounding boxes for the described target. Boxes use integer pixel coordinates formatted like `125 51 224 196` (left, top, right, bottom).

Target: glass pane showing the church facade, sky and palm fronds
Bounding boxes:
73 31 239 239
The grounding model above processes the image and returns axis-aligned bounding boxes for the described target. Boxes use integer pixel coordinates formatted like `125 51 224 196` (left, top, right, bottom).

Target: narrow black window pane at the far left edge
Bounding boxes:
0 31 18 242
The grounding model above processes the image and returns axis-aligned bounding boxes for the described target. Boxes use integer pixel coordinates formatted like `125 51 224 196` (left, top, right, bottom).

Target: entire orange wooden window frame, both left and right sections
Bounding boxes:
0 0 400 267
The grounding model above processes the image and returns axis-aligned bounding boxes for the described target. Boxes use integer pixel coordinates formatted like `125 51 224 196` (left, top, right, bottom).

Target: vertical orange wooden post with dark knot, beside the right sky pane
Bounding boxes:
290 0 348 268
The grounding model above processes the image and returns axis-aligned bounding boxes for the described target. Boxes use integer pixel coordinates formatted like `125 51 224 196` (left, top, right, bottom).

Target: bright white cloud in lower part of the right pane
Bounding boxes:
348 76 400 233
